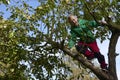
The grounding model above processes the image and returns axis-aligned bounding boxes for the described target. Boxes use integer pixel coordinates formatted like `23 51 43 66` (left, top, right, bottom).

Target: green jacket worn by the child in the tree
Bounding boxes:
69 19 98 48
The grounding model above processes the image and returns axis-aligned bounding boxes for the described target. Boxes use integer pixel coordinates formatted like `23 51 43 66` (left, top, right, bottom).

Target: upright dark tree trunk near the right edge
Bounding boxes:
108 31 120 80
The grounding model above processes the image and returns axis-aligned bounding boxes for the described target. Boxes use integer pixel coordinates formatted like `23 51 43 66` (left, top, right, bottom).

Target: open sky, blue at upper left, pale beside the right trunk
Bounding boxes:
0 0 120 80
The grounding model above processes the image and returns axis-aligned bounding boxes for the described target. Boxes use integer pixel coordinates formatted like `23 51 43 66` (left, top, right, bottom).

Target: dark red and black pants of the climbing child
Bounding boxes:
76 41 107 68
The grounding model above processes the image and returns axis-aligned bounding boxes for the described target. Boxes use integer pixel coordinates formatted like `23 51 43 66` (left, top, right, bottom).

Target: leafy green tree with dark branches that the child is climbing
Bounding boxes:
0 0 120 80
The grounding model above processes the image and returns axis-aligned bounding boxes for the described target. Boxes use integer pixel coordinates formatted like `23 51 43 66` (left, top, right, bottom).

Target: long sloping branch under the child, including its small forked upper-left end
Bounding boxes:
54 41 112 80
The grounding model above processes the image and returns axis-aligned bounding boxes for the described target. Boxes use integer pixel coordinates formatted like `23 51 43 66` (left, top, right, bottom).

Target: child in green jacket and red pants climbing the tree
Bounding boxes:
68 15 107 69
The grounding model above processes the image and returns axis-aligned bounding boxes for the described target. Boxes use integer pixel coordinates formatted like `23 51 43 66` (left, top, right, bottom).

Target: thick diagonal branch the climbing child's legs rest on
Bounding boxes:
62 47 110 80
